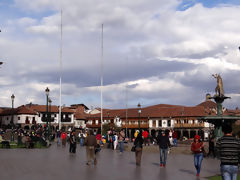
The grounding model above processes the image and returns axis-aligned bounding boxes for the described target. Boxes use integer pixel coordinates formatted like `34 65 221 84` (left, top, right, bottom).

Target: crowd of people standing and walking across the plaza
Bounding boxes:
0 125 240 180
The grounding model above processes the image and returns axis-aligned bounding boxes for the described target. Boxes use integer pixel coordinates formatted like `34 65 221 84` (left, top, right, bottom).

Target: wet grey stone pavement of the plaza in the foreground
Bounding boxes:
0 144 219 180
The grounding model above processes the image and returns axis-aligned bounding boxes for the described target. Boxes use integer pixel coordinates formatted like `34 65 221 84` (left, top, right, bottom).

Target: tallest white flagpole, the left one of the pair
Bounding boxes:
58 7 63 130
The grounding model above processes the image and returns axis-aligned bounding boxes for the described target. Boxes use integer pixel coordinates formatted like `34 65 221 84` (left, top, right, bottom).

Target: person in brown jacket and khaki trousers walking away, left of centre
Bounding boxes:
85 130 97 165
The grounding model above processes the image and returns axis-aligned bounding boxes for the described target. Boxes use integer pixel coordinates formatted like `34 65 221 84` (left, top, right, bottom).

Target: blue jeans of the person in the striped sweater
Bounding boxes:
221 165 238 180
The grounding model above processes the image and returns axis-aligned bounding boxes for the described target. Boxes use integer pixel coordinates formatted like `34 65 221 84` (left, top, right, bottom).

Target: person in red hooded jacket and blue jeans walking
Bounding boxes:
191 135 204 176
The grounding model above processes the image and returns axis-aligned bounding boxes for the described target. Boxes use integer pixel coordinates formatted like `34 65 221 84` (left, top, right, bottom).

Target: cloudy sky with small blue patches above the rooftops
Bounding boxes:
0 0 240 109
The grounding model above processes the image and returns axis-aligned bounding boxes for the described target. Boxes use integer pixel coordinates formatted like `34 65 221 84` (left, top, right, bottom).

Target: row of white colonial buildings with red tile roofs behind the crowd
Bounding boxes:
0 94 239 141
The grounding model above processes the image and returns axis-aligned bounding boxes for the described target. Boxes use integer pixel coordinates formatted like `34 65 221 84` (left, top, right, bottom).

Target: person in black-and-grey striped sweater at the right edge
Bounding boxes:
216 125 240 180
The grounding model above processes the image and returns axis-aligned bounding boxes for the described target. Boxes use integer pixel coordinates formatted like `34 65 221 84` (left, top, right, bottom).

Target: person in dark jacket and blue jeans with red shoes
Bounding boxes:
157 131 170 167
